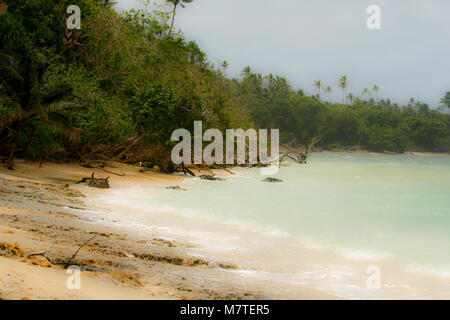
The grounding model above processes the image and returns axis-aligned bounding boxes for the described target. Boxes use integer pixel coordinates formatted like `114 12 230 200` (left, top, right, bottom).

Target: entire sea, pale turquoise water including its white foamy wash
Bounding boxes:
87 153 450 298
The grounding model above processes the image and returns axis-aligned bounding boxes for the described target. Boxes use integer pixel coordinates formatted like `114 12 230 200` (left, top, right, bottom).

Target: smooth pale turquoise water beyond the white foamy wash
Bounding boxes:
147 154 450 276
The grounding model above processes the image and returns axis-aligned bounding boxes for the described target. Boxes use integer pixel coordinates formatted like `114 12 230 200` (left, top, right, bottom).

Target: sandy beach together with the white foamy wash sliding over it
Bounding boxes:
0 154 448 300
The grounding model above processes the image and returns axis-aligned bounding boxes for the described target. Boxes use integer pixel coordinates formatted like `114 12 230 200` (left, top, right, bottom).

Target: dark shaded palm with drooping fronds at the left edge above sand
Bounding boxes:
0 54 83 170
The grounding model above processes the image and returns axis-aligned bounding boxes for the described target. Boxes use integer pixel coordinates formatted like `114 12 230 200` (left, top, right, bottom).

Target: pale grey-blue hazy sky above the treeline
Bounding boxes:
116 0 450 107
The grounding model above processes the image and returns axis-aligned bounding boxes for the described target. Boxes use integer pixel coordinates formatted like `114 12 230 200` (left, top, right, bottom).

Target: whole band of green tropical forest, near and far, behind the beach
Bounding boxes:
0 0 450 166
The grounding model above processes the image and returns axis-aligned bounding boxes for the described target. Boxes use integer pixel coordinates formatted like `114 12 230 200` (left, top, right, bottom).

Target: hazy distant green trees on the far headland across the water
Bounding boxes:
239 68 450 152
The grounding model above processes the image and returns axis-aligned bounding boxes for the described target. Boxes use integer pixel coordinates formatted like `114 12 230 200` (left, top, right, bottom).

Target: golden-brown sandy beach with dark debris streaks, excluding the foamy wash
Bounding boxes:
0 160 334 299
